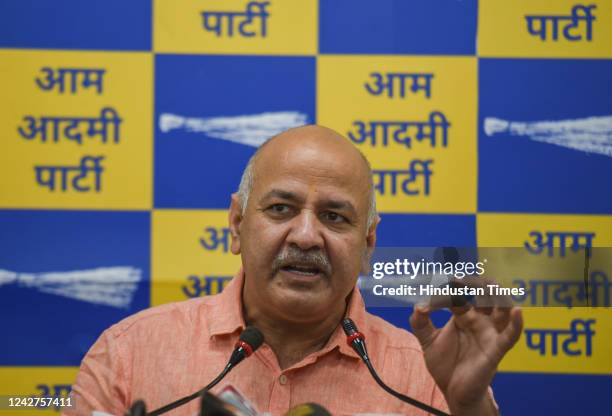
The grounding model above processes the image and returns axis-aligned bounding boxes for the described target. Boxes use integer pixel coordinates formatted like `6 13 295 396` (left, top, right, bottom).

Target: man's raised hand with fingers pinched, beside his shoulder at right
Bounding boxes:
410 306 523 416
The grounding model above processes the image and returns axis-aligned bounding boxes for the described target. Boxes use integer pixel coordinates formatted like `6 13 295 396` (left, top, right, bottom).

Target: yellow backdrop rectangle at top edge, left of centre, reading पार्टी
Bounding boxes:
153 0 319 55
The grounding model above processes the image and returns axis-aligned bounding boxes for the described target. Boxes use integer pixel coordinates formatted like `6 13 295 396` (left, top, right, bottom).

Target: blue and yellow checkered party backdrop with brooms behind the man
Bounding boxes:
0 0 612 415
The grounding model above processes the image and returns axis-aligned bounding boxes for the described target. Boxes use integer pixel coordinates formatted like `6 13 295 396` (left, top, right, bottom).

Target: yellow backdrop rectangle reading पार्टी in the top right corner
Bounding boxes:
478 0 612 58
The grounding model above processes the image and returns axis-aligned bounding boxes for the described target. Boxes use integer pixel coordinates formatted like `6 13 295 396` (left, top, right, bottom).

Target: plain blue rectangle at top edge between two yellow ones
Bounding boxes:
319 0 478 55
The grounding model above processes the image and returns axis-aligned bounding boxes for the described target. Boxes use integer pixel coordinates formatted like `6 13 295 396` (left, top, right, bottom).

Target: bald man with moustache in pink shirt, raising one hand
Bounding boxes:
65 126 522 416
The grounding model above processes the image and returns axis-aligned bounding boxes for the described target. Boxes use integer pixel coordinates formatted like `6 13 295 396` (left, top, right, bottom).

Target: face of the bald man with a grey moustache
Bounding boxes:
230 135 375 322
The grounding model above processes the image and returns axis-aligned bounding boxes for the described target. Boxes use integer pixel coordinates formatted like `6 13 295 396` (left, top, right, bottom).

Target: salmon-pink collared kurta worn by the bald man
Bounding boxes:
63 272 448 416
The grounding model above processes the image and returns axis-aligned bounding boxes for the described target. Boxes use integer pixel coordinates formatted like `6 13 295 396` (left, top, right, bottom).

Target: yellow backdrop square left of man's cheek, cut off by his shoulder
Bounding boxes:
151 210 241 306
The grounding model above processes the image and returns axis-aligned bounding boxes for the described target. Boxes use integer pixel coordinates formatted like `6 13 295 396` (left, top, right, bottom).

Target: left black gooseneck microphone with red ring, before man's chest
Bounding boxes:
147 326 263 416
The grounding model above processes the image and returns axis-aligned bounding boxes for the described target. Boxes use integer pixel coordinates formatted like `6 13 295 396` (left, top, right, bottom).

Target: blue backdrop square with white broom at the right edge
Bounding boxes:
478 59 612 214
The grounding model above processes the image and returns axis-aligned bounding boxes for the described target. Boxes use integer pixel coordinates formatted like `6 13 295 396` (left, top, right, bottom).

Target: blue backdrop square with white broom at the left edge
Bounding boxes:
0 210 150 366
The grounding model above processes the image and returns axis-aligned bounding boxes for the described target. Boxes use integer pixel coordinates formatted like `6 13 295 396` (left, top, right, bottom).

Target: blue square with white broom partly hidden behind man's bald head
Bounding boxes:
154 55 316 209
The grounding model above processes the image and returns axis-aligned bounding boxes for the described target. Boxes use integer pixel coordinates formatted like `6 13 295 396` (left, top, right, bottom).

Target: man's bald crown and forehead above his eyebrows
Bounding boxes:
245 126 371 211
